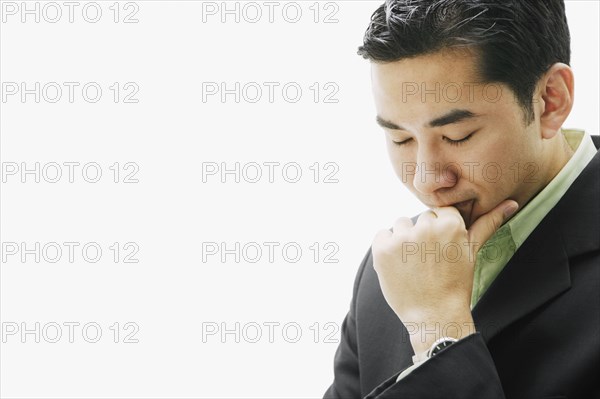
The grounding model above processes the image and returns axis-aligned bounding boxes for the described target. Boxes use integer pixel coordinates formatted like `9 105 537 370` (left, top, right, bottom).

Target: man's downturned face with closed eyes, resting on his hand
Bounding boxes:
372 52 548 228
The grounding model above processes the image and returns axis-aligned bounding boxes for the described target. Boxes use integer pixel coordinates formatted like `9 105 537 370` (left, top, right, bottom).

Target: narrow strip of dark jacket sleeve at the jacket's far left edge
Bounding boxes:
323 248 371 399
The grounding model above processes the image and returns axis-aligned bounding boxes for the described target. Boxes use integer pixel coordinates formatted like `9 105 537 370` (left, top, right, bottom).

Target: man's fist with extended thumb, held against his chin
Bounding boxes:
371 200 519 353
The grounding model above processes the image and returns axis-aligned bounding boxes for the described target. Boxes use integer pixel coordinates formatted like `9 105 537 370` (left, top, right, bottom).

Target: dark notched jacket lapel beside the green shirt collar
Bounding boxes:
473 136 600 342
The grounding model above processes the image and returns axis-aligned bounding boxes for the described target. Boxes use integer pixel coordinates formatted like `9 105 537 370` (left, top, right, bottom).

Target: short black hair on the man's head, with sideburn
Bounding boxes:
358 0 571 124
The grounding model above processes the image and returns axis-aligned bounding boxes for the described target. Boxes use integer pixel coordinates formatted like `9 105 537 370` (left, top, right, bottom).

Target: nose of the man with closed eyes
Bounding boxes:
413 148 459 195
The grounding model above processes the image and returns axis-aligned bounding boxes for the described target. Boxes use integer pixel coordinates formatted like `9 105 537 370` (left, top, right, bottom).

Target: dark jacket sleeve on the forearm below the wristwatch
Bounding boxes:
365 332 505 399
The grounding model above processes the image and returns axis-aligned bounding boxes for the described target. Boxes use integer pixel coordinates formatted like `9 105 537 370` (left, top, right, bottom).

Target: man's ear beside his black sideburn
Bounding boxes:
538 63 574 139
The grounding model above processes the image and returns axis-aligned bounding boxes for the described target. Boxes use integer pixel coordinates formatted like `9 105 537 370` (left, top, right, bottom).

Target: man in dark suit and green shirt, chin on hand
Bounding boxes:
325 0 600 399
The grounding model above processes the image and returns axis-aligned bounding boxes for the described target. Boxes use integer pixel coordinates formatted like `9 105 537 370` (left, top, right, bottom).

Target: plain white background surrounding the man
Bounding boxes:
0 1 600 398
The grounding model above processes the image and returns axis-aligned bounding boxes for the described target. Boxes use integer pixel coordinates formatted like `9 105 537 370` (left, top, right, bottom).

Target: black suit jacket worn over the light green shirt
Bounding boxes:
325 136 600 399
